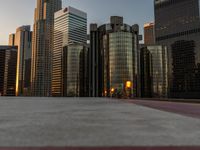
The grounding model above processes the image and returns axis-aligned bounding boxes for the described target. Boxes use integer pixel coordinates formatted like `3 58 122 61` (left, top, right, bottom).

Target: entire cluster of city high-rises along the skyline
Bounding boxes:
0 0 200 98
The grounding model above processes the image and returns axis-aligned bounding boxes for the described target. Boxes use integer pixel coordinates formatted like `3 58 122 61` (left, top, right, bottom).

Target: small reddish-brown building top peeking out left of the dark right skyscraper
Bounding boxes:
144 22 155 44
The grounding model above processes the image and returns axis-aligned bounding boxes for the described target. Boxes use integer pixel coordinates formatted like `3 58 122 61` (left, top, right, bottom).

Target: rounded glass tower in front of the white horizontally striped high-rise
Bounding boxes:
63 44 88 97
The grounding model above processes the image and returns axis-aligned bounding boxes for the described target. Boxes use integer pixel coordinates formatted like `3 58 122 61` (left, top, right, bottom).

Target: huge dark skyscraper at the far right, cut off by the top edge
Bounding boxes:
154 0 200 98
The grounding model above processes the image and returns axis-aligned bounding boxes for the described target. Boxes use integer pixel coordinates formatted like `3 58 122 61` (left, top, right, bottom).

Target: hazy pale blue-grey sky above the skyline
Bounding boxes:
0 0 154 45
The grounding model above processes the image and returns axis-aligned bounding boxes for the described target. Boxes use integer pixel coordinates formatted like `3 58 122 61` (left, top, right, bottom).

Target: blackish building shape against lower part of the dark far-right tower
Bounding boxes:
172 40 198 97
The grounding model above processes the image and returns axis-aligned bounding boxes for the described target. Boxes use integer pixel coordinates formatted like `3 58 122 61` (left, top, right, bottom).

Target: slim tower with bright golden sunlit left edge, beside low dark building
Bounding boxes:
15 26 32 96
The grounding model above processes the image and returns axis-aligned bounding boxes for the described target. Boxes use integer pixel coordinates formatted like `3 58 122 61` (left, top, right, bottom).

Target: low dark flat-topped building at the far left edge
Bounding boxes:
0 46 18 96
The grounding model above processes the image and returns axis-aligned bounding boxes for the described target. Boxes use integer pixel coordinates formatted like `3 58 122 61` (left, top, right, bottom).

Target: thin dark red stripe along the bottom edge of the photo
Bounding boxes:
0 146 200 150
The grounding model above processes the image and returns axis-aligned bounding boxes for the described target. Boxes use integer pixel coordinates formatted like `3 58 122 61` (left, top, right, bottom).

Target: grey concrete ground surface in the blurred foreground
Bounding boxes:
0 97 200 147
